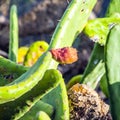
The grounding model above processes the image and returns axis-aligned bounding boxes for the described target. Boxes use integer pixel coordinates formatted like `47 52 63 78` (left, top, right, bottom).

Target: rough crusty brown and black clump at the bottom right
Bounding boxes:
68 83 112 120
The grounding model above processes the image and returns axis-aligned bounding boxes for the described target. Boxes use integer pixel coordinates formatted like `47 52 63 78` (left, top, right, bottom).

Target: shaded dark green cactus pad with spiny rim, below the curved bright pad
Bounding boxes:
0 70 63 120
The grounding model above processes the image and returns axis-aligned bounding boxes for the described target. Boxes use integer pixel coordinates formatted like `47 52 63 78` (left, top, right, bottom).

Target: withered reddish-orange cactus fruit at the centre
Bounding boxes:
50 47 78 64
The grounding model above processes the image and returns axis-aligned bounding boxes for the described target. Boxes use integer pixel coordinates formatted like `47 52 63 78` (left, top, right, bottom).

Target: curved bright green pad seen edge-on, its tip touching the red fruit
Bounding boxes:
0 52 52 104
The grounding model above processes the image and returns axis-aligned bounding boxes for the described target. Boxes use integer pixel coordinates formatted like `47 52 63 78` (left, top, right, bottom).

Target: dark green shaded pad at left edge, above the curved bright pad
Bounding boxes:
0 56 28 86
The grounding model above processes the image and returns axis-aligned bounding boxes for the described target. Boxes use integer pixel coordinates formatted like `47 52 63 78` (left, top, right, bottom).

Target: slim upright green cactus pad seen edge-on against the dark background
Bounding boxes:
9 5 18 62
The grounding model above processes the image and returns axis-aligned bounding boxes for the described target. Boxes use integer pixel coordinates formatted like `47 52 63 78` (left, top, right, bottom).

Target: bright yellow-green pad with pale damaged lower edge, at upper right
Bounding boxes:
84 15 120 45
